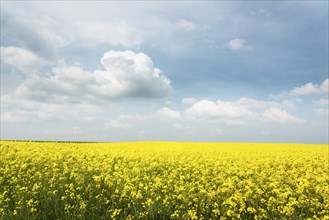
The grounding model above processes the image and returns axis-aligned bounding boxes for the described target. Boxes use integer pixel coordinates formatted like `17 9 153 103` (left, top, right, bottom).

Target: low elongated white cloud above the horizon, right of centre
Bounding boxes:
184 97 305 126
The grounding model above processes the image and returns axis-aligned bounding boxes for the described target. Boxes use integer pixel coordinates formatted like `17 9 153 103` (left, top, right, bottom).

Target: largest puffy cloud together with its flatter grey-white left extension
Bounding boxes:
7 51 172 103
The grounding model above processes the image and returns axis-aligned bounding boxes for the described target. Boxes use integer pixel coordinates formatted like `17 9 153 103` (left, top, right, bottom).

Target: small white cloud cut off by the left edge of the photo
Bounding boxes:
1 47 47 73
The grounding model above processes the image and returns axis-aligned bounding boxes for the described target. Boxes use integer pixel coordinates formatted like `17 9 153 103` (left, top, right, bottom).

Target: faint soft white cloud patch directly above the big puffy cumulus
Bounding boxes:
79 20 144 48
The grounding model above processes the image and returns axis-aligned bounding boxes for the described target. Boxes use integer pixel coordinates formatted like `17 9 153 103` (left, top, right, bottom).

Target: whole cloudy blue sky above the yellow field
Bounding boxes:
1 1 329 143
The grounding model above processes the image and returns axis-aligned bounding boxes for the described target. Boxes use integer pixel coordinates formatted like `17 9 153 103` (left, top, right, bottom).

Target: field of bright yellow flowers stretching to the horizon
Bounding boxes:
0 141 329 220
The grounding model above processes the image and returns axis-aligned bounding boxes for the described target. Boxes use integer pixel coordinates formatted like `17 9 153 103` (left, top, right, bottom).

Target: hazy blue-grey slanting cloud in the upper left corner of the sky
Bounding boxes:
1 7 68 60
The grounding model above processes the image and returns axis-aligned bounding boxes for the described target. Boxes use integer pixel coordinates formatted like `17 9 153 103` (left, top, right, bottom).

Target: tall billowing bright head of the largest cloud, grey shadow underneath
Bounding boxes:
95 51 172 98
